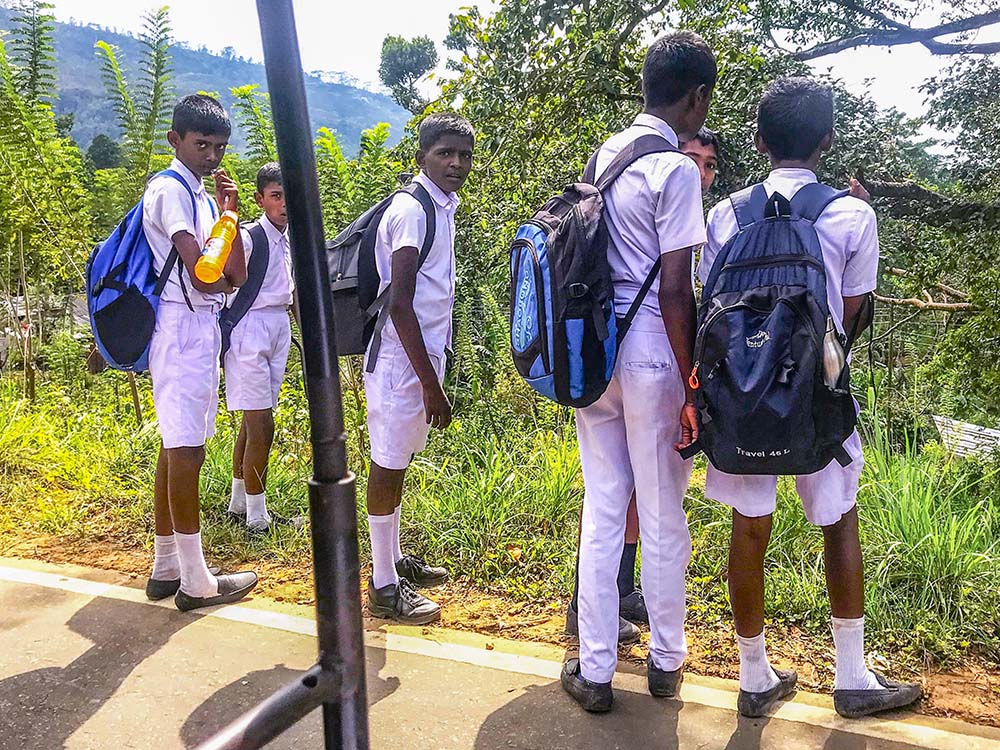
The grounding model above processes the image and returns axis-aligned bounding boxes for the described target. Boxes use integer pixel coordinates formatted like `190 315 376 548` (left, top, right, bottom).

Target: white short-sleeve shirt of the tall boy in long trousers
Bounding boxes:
597 113 705 318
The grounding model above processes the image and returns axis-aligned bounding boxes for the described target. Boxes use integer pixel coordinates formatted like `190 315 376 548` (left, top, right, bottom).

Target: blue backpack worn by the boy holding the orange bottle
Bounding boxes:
86 169 215 372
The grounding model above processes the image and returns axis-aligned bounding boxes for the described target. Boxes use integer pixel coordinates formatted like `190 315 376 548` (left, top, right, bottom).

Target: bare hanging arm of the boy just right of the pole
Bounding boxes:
389 247 451 429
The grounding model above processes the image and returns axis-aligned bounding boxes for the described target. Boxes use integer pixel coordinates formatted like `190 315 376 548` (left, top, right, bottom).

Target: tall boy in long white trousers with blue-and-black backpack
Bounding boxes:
562 32 716 711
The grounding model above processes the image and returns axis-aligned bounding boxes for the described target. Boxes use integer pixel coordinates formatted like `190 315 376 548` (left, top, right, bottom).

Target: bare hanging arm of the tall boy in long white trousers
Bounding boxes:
658 247 698 450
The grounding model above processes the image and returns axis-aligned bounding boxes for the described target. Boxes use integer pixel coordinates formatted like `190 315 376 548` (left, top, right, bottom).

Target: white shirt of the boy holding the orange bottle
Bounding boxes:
142 159 225 307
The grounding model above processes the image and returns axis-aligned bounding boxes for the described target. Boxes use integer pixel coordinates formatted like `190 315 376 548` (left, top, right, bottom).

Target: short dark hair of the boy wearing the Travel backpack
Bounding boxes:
757 76 833 160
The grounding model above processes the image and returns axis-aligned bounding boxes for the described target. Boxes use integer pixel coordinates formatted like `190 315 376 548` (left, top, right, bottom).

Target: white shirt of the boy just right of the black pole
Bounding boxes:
375 173 458 356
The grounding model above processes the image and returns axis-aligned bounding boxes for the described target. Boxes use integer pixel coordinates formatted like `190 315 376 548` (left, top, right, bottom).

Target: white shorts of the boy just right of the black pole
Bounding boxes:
365 339 445 470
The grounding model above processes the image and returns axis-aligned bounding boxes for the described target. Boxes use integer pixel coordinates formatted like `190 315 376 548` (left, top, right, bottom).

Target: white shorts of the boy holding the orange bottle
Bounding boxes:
149 301 222 448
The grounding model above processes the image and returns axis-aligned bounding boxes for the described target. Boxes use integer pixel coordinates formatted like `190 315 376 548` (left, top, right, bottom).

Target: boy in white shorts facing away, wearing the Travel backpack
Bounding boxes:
698 78 920 718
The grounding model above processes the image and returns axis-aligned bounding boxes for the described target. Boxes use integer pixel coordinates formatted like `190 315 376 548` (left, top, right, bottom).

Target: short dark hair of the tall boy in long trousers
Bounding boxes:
642 31 718 107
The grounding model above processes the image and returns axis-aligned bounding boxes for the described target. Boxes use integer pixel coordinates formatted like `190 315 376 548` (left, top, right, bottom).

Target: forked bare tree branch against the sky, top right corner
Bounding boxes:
792 9 1000 60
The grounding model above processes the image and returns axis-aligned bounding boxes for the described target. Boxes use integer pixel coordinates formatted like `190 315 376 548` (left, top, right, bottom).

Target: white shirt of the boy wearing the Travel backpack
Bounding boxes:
698 169 879 329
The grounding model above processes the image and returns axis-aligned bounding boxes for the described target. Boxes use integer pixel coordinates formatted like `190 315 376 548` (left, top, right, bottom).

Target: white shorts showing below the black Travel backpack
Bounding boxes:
705 430 865 526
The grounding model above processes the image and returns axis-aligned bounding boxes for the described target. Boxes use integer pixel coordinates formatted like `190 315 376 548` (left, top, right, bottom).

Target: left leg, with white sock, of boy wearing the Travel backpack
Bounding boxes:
728 509 780 696
